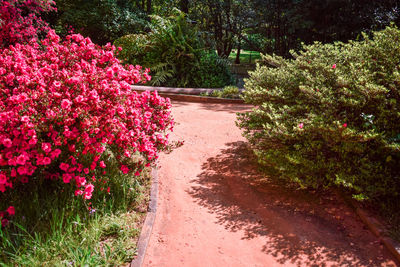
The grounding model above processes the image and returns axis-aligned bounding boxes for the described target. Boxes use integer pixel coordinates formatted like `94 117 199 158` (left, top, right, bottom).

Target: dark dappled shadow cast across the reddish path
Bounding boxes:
189 142 392 266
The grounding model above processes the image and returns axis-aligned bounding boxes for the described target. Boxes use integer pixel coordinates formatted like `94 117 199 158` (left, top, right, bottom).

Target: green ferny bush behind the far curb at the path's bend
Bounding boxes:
114 10 232 87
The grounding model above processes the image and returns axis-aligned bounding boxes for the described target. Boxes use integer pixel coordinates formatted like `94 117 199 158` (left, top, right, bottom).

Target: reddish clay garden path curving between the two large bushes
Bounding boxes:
144 102 396 267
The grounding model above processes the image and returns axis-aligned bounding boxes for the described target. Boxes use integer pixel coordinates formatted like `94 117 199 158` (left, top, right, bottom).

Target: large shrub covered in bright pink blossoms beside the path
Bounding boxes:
0 30 173 215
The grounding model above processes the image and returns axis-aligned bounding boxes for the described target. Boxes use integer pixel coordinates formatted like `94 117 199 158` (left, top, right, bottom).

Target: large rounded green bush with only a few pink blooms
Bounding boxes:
238 27 400 199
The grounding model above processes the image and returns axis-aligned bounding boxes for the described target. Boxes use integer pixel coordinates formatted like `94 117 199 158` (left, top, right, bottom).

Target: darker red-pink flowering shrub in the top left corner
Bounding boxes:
0 0 56 48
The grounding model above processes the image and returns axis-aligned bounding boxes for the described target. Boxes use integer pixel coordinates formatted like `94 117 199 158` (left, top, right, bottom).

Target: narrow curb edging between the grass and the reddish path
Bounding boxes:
130 167 158 267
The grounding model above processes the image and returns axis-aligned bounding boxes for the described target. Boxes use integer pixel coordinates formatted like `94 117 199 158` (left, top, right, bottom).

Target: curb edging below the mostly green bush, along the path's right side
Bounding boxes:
339 192 400 266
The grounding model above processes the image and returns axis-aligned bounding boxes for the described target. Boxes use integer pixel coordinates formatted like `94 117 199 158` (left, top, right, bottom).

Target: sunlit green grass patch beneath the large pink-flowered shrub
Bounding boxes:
0 163 150 266
